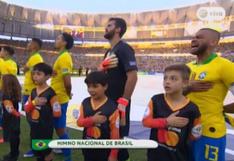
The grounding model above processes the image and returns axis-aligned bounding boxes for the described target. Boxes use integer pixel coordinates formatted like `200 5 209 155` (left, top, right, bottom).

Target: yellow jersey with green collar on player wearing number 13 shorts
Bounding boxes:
188 54 234 138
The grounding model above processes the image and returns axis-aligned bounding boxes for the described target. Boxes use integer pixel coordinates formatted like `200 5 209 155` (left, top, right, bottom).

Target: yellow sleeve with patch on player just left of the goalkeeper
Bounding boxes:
60 54 73 75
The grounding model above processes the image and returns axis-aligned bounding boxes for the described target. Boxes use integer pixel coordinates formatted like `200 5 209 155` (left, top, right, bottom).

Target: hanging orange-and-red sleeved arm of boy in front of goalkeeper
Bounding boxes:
109 110 120 160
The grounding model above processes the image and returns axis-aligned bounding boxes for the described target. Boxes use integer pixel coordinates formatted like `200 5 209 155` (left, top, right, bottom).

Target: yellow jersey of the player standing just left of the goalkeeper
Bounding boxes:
51 50 73 104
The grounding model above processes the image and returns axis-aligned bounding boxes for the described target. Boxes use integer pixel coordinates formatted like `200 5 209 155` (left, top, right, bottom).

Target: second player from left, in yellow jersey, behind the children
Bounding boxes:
22 38 43 157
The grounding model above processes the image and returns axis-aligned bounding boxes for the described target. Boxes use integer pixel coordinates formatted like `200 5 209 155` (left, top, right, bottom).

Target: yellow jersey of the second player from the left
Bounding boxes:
23 52 43 95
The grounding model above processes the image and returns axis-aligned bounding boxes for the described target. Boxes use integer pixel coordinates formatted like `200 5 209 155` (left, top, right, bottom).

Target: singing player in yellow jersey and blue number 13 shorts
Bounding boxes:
188 28 234 161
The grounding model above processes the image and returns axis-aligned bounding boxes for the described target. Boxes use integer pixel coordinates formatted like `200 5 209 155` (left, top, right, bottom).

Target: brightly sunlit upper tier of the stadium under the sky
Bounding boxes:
0 0 234 41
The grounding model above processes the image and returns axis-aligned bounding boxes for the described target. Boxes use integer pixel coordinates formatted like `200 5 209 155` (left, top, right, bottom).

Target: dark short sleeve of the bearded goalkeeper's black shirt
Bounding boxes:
118 44 137 72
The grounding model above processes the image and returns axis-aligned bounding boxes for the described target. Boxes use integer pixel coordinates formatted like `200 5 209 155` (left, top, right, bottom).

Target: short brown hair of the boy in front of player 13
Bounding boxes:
164 64 191 80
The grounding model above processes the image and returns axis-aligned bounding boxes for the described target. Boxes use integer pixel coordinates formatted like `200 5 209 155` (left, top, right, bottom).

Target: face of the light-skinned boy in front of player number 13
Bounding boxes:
163 70 187 94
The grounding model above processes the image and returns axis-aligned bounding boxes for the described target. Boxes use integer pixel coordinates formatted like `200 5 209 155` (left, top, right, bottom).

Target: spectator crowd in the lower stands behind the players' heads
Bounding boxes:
0 39 234 73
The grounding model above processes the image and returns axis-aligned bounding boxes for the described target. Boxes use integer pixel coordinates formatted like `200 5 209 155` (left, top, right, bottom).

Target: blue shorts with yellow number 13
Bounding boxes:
192 135 226 161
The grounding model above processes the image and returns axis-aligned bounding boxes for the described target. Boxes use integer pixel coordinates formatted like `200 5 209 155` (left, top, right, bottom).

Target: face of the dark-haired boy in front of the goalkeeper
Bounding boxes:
87 83 107 99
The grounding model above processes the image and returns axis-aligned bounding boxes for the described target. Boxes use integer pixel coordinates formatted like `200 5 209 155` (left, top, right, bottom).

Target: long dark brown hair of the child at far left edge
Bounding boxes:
2 74 21 102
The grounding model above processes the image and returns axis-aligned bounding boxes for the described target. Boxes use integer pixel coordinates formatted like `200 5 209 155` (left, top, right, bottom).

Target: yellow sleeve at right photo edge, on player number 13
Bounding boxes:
220 60 234 88
